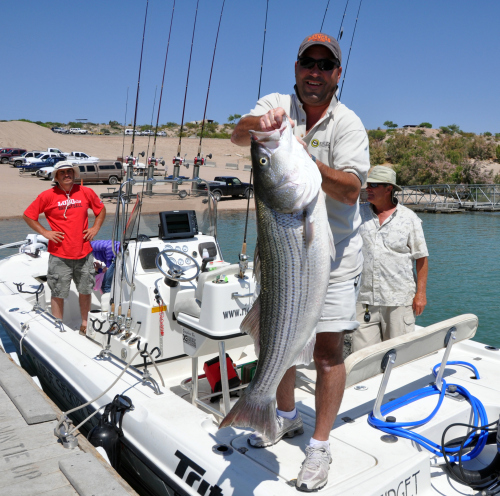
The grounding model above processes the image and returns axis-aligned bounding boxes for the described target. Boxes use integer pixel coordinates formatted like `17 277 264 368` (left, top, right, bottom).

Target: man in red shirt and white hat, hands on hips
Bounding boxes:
23 161 106 334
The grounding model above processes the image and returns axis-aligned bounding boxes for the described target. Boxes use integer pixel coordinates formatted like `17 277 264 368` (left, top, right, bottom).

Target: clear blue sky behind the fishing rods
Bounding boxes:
0 0 500 133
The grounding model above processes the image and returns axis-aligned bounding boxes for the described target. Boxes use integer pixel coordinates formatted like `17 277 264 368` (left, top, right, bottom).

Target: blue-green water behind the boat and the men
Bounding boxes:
0 212 500 347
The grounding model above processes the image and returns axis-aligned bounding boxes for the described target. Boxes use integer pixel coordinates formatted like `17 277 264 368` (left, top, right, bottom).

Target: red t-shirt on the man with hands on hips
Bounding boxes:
24 184 104 260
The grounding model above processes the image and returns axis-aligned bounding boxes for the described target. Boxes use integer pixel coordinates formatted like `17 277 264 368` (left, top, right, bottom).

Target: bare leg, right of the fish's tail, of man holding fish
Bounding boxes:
312 332 345 441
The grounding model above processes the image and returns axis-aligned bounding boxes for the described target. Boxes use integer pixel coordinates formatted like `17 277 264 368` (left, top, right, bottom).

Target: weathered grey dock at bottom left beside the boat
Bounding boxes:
0 348 137 496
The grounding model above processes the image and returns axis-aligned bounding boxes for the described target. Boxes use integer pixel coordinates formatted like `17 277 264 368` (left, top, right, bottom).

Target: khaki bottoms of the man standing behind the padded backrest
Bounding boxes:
352 303 415 353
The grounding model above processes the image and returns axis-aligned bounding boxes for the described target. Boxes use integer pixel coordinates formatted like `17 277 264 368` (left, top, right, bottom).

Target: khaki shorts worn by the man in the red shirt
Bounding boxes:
47 253 95 298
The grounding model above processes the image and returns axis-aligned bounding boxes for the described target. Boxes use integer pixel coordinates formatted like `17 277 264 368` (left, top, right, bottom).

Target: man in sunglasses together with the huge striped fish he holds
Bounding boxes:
229 33 370 492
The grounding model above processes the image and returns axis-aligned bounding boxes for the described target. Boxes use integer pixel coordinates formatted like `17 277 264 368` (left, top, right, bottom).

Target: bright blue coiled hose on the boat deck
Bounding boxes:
368 361 488 462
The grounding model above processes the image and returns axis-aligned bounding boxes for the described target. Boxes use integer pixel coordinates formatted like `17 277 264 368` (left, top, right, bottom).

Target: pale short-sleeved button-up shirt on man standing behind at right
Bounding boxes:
358 203 429 307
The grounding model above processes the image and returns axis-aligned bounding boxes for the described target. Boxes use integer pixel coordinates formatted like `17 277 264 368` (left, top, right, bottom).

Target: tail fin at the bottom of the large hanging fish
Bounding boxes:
219 386 277 442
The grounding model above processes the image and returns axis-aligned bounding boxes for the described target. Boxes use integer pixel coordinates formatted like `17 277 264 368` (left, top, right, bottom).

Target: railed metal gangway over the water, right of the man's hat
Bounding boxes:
396 184 500 214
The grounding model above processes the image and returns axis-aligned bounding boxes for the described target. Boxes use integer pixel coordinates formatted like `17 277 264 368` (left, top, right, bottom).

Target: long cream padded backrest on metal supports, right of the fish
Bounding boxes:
345 314 478 388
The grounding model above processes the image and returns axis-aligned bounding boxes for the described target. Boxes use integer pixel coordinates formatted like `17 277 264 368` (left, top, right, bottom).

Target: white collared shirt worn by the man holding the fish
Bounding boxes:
243 93 370 282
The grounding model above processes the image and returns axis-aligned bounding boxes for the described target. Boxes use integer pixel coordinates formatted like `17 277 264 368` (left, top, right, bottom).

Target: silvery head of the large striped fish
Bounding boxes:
250 117 321 213
